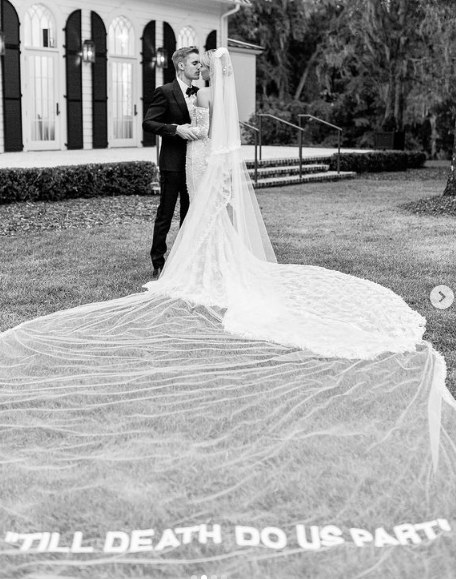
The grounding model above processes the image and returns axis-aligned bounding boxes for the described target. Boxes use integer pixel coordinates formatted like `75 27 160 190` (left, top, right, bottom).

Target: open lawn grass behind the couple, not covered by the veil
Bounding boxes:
0 168 456 392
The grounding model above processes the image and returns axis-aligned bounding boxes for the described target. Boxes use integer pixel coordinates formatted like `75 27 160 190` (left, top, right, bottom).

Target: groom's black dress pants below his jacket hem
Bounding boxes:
150 171 189 268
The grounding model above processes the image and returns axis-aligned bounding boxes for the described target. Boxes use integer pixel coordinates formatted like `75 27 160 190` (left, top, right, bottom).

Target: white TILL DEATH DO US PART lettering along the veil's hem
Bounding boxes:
5 519 451 554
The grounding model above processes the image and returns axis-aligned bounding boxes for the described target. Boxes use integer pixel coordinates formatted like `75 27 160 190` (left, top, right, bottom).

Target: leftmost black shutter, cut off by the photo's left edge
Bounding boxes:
0 0 24 152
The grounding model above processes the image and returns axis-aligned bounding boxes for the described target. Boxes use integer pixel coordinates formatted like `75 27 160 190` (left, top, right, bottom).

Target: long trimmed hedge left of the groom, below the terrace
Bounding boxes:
0 161 157 204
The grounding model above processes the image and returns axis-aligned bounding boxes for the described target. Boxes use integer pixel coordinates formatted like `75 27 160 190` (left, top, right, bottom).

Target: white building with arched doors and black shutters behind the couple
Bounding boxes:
0 0 258 152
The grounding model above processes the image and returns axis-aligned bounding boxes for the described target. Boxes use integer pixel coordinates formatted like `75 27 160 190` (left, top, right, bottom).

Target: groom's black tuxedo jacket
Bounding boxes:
143 79 199 171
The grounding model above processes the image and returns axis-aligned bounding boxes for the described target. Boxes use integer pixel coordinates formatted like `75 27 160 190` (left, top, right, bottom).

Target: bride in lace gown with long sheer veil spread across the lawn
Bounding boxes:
0 48 456 579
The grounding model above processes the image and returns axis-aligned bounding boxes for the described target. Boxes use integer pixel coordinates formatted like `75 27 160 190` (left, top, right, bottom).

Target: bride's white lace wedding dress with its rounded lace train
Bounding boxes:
146 101 425 359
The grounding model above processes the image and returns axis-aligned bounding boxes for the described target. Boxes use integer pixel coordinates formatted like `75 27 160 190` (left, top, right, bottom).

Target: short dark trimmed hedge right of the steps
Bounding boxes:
329 151 426 173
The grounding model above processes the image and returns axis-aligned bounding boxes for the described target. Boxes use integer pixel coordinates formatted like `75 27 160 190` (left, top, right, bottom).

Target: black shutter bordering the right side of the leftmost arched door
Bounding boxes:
65 10 84 149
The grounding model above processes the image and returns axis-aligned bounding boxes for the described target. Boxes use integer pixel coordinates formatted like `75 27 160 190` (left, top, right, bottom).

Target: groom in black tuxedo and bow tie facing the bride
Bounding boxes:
143 46 201 280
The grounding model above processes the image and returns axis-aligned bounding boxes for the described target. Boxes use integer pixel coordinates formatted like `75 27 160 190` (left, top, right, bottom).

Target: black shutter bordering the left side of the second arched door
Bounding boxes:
90 12 108 149
